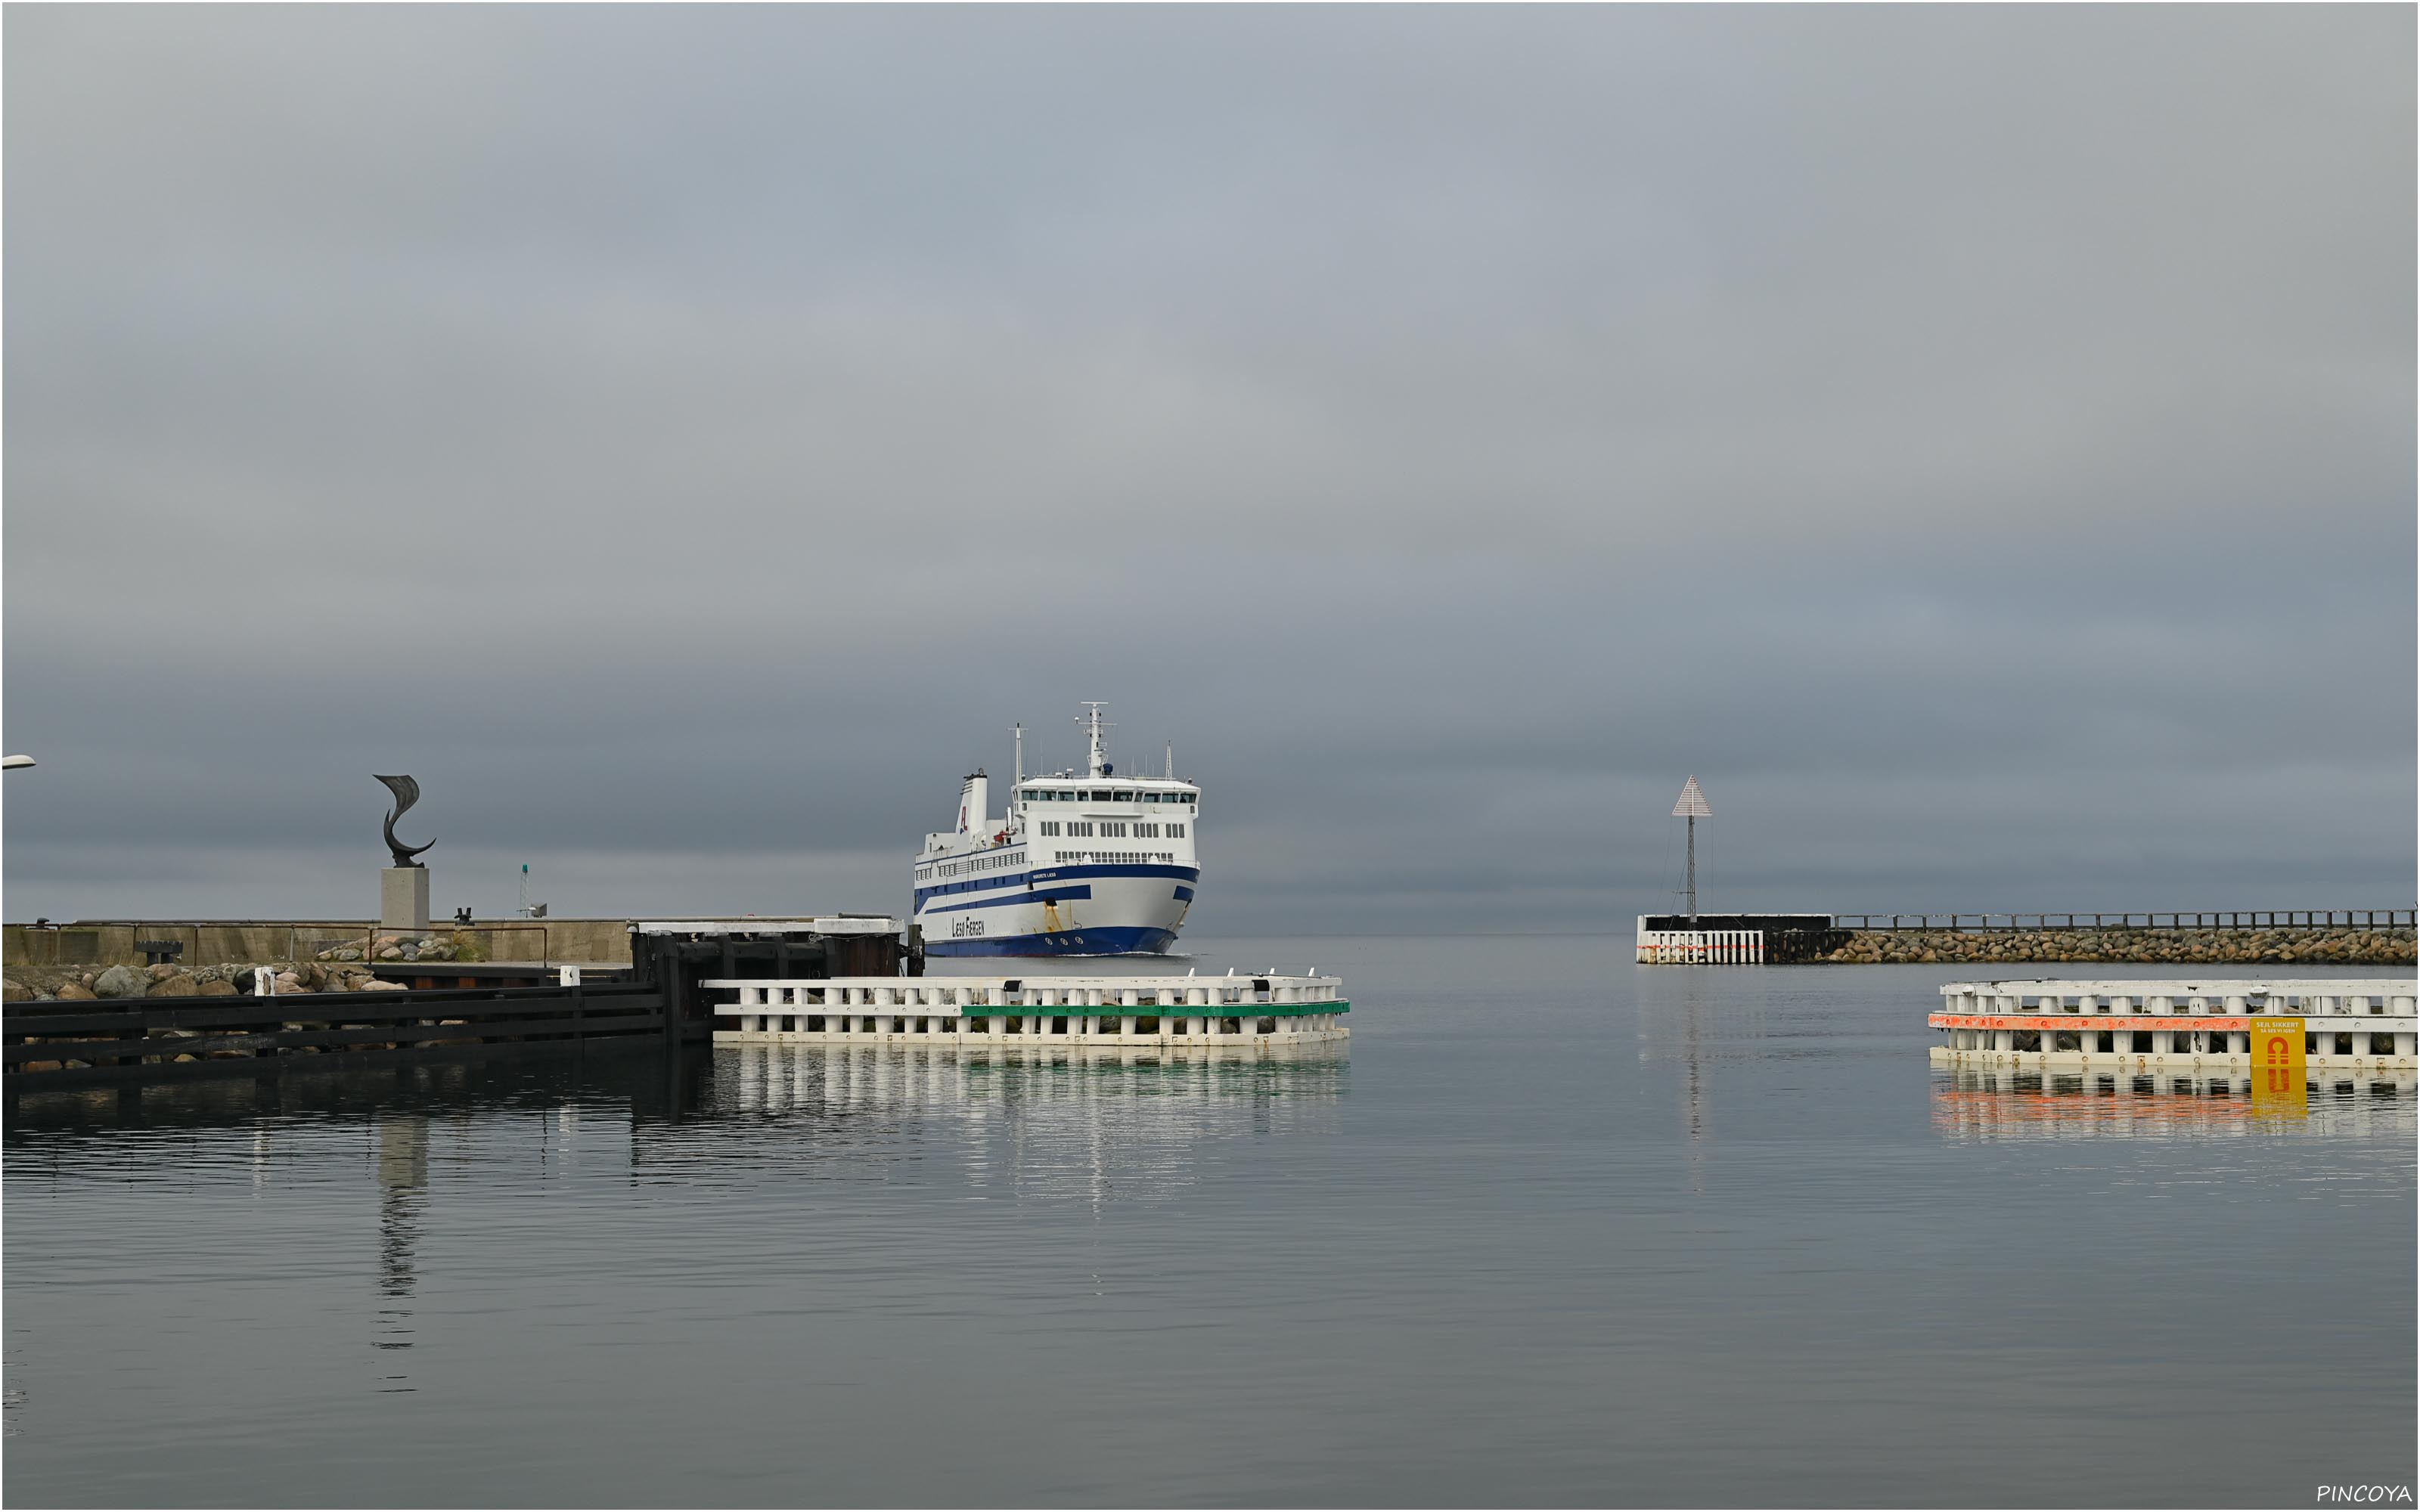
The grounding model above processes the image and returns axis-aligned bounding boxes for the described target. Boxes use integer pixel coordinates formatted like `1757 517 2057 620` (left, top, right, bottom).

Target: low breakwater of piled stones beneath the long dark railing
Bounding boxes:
1815 927 2415 965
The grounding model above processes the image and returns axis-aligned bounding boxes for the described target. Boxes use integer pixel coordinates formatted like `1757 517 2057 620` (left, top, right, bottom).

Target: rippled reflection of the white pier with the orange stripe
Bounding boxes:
1934 1072 2420 1139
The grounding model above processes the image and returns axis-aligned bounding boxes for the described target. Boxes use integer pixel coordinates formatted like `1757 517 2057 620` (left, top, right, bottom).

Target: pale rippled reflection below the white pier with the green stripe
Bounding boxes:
631 1045 1351 1202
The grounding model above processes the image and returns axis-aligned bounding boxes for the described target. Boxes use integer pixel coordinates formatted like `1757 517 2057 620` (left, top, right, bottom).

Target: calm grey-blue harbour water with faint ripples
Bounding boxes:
5 939 2420 1504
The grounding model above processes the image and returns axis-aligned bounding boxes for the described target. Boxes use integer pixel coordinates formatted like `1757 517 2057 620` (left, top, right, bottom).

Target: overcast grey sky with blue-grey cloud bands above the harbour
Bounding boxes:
5 5 2415 934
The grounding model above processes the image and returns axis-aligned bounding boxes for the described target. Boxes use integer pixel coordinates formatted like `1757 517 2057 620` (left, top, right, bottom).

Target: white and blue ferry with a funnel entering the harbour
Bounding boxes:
912 702 1200 956
